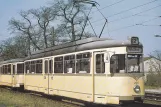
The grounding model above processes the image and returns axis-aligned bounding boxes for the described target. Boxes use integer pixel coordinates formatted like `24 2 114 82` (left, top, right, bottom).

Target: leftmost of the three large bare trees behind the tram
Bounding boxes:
9 11 40 52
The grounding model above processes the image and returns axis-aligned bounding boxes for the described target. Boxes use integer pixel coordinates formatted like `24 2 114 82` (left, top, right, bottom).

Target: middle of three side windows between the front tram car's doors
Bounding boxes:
64 55 75 73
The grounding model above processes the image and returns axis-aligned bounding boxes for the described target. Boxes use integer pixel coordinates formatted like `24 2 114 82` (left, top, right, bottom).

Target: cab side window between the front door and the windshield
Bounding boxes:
110 54 125 73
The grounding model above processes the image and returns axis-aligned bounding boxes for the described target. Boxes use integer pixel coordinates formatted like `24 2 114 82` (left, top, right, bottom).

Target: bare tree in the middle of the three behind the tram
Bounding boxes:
29 7 58 48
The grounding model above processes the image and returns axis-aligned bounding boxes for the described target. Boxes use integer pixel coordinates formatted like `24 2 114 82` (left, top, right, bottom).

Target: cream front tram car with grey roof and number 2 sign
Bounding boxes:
24 37 144 104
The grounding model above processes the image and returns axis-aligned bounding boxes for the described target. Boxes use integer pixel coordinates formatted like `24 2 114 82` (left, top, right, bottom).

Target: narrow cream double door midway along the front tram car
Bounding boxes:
44 59 53 94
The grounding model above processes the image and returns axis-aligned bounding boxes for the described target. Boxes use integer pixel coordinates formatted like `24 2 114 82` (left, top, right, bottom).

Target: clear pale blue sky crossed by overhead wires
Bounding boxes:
0 0 161 56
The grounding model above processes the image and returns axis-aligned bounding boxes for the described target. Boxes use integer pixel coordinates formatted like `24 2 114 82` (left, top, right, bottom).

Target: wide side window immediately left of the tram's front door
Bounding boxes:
76 52 90 73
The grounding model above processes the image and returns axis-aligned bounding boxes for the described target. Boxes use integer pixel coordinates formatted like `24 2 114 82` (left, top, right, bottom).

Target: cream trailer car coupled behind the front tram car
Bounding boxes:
0 59 24 88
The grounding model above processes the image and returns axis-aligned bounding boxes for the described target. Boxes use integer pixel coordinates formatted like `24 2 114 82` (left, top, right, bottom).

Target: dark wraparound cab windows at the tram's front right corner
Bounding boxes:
110 54 142 73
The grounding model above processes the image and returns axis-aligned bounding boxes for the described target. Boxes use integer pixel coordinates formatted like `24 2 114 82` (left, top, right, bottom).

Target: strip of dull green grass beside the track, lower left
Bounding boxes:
0 88 80 107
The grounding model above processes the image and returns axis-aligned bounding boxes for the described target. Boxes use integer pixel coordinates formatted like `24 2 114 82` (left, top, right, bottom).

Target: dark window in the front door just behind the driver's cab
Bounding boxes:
96 54 105 73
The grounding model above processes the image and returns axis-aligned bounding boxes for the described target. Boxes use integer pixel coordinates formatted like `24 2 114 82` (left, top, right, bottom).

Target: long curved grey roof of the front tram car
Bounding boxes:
26 37 142 59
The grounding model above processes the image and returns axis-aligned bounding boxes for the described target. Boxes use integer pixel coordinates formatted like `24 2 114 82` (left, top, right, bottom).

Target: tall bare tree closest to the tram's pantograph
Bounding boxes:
52 0 91 41
